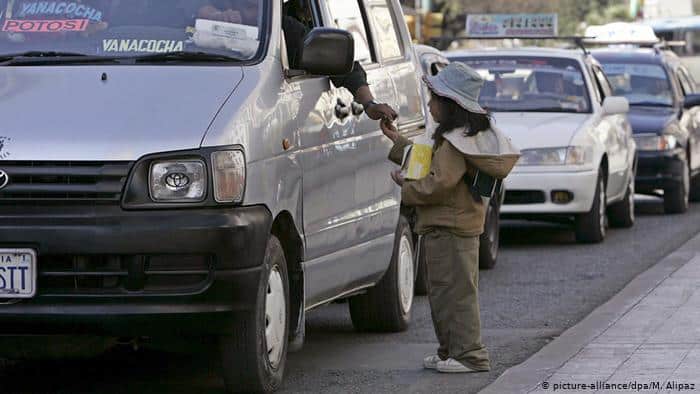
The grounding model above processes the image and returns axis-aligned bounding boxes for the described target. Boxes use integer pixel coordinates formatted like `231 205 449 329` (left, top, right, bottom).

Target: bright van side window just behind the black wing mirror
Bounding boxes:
328 0 372 63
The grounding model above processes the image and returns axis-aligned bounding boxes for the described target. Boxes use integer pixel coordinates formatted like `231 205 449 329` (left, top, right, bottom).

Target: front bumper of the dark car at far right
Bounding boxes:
635 149 685 193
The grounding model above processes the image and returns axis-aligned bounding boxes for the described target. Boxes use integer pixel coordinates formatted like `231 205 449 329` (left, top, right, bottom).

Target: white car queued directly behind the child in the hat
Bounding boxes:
447 48 637 242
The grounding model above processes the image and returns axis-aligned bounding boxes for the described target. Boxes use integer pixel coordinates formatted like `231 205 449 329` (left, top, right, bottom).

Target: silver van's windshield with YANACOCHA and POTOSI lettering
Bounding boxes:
0 0 264 60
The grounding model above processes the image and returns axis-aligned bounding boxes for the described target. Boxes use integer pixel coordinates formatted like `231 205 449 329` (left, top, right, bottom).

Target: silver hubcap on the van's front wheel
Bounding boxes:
265 266 287 368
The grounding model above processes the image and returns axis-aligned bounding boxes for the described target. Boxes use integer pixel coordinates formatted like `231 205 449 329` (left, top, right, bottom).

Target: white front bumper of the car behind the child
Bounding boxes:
501 170 598 217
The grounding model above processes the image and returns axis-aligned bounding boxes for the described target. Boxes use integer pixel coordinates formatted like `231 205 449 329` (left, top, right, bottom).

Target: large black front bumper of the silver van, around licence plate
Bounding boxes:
0 206 272 335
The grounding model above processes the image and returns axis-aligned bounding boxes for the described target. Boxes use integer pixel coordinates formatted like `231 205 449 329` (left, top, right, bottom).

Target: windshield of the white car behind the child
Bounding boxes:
456 56 590 113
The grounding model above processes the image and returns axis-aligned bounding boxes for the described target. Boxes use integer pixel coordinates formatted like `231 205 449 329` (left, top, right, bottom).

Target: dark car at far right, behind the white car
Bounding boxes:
593 48 700 213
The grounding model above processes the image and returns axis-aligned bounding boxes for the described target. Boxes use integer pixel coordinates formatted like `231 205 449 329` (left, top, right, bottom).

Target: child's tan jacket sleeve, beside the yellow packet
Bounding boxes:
401 141 467 206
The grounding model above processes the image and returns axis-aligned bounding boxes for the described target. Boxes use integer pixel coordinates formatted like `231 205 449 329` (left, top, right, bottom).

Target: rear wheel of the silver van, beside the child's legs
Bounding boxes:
349 217 415 332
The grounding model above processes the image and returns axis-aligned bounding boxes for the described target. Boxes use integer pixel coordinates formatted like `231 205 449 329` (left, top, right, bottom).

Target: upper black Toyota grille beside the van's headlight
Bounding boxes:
0 161 131 204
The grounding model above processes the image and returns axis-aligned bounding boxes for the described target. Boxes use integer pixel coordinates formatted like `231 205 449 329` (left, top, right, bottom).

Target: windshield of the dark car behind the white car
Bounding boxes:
603 63 673 107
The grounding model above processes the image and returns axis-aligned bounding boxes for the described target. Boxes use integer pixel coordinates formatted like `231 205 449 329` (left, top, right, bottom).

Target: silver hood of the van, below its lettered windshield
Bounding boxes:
0 66 243 161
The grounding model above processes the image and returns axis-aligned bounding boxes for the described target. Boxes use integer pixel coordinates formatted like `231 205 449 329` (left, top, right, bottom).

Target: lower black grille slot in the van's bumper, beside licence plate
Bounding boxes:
37 255 214 296
